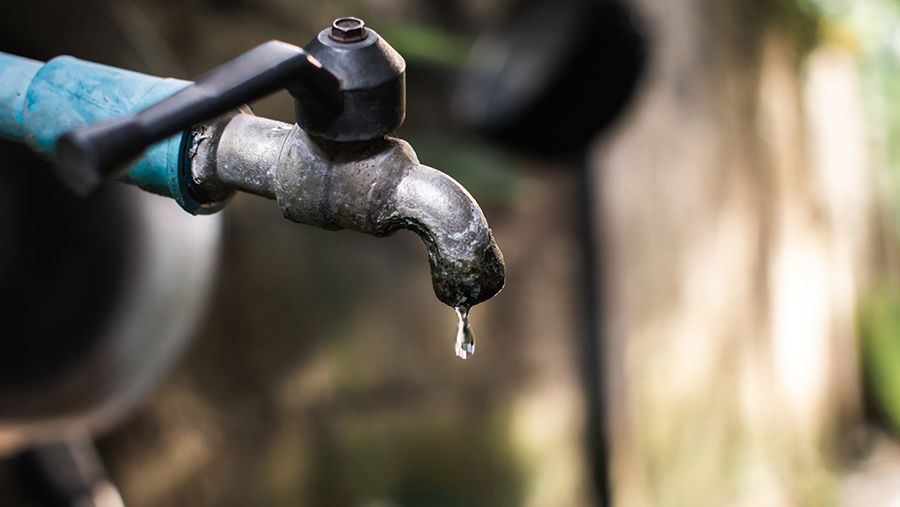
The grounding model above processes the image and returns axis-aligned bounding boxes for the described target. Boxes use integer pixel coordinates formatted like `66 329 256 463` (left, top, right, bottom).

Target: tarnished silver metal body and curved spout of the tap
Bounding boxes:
195 115 505 307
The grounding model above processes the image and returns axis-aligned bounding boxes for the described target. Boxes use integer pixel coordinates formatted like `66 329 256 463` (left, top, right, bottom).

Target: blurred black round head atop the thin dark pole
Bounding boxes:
456 0 646 156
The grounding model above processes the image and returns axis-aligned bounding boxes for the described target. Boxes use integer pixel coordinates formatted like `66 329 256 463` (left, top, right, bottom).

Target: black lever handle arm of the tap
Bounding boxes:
56 41 342 195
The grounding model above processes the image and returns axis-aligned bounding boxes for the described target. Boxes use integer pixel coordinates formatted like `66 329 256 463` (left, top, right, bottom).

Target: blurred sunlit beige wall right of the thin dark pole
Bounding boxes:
594 0 873 506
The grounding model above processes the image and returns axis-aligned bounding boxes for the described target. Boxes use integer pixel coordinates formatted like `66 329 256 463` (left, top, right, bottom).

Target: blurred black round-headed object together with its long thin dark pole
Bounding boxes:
457 0 646 505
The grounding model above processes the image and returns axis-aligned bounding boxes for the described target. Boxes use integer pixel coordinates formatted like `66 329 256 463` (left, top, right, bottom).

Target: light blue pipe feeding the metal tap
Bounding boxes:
0 52 207 214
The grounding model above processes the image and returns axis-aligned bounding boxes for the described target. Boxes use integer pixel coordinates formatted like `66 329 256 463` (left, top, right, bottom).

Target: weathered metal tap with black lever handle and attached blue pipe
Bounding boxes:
0 17 505 312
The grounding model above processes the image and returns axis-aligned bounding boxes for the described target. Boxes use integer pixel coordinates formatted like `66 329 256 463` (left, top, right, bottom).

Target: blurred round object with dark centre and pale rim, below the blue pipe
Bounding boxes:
0 144 219 455
